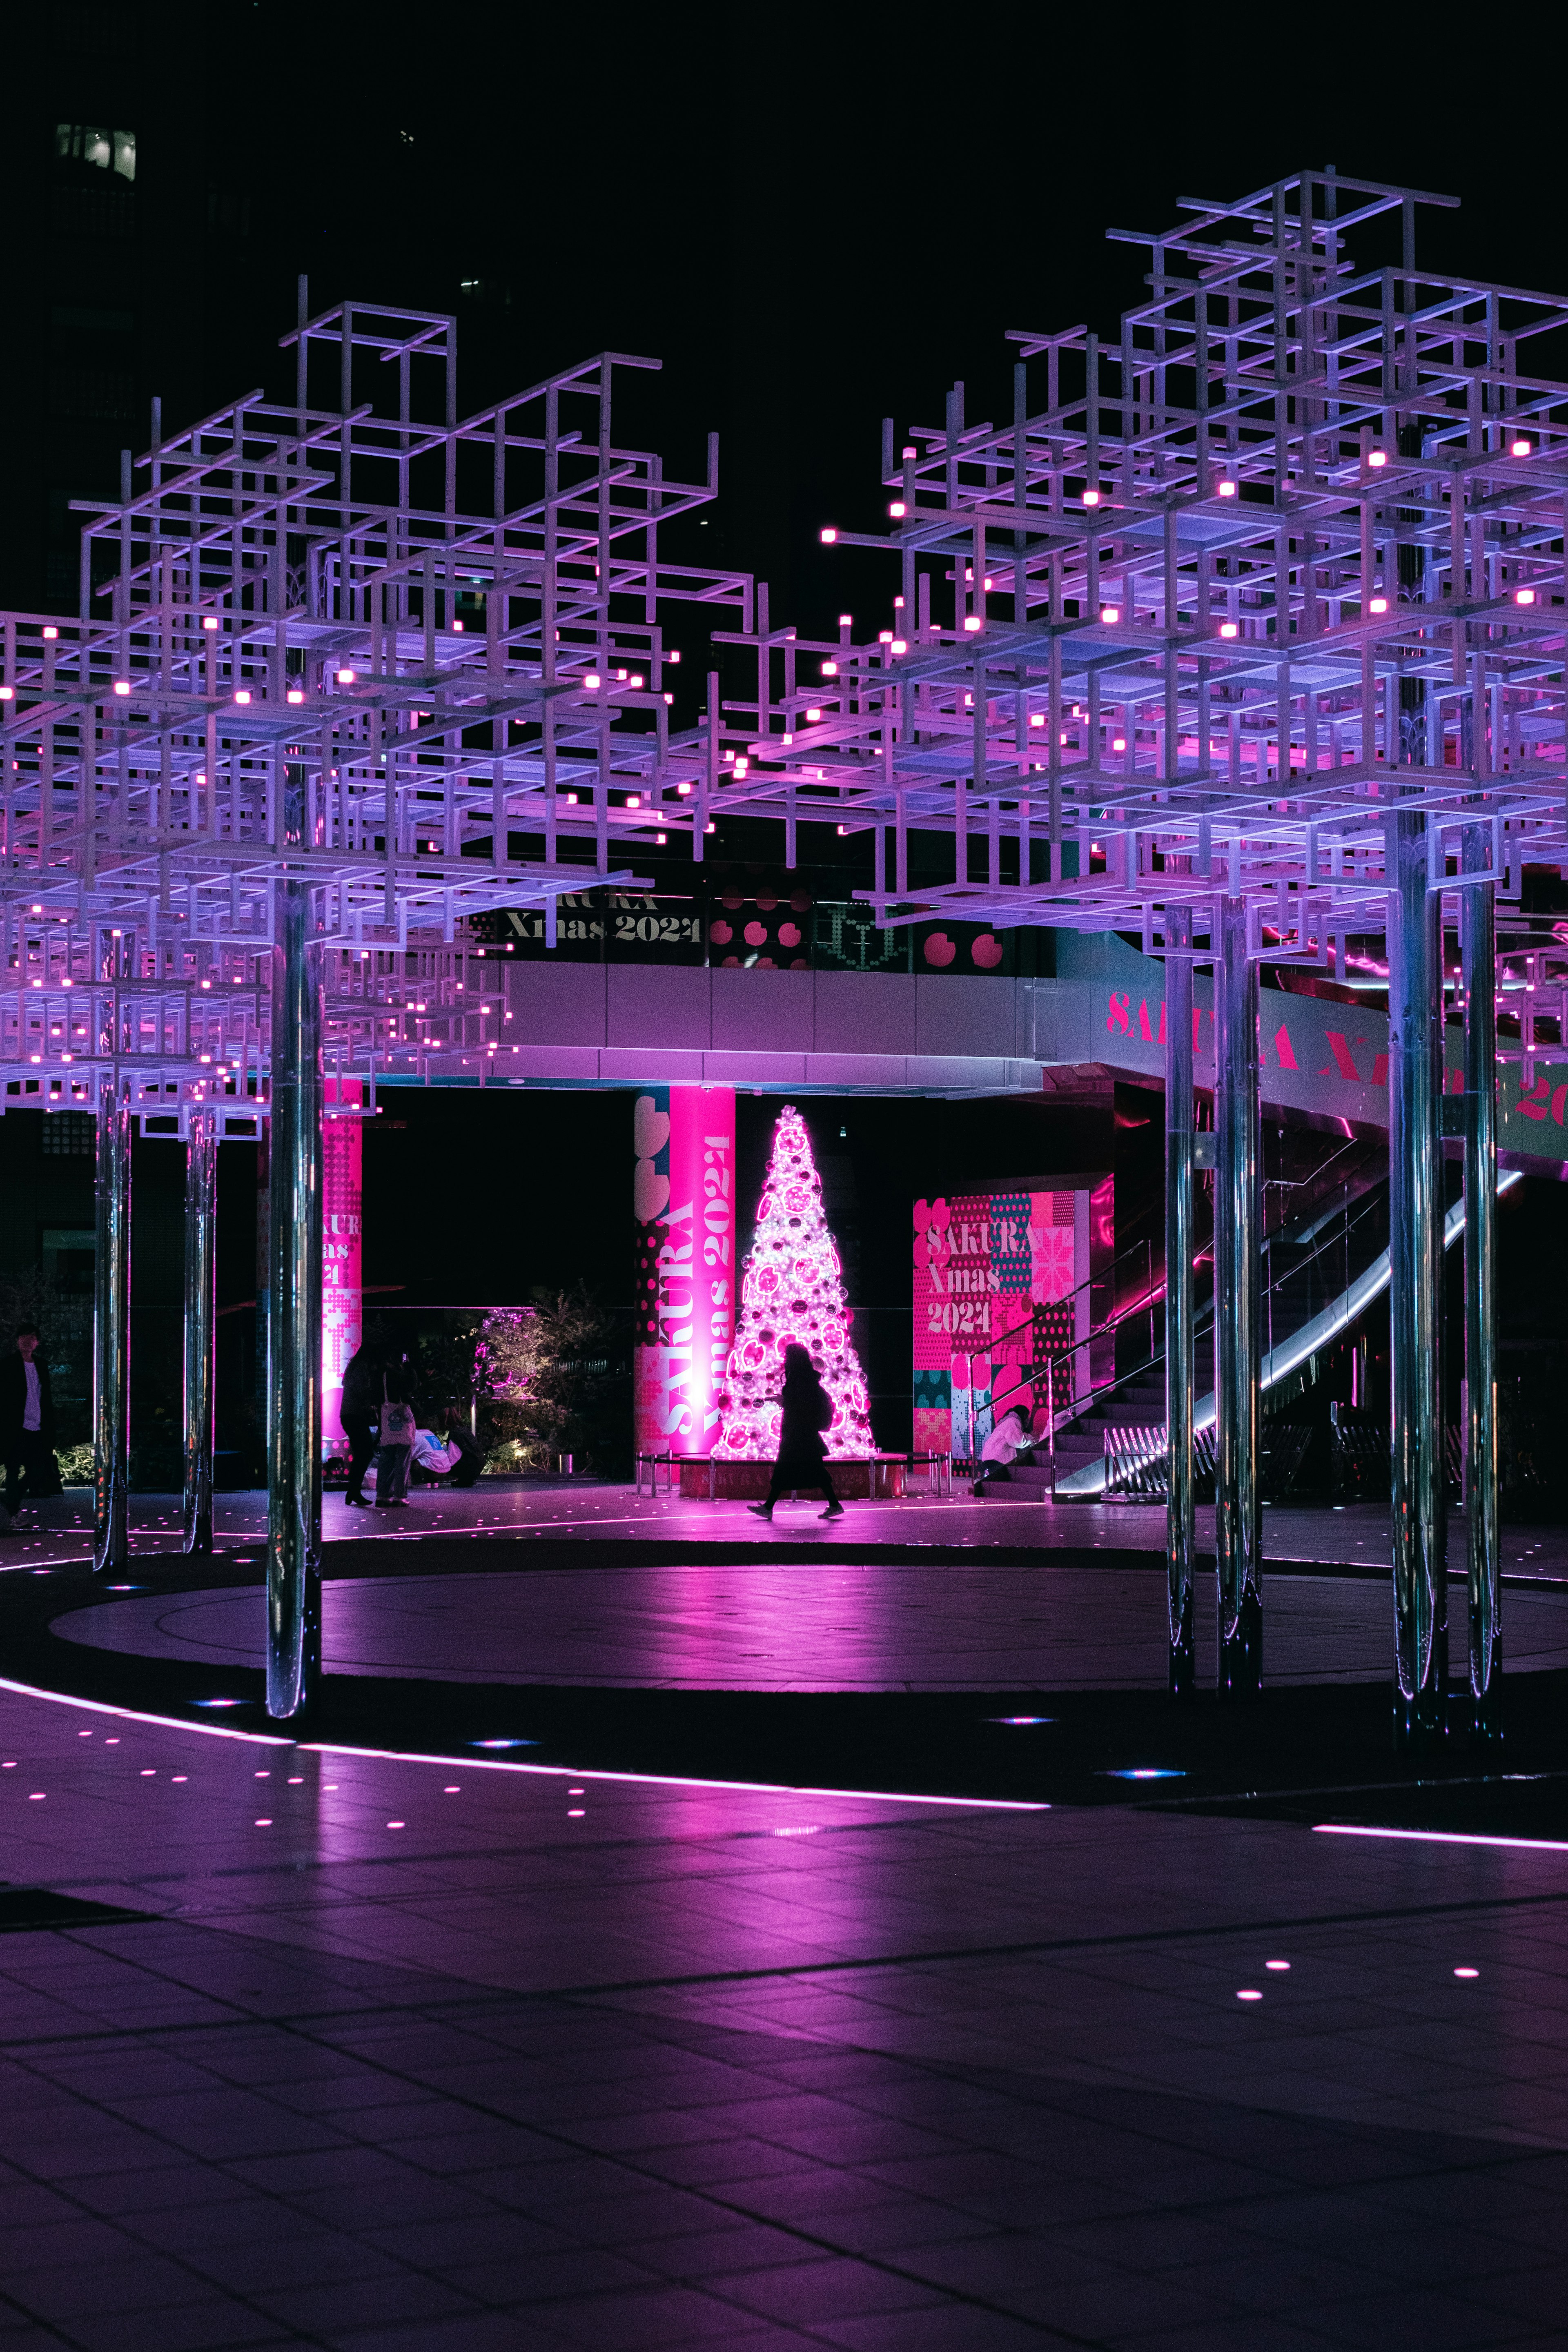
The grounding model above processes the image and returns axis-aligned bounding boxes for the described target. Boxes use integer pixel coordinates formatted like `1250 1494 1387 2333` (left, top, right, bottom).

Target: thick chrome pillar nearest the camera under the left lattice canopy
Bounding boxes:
266 882 322 1717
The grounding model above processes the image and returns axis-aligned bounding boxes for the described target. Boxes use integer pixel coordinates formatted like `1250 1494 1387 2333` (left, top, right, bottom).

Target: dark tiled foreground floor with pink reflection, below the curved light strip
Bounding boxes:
0 1693 1568 2352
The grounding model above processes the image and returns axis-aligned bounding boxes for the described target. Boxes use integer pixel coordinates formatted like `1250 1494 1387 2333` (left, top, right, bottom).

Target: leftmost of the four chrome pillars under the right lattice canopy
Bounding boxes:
1166 908 1192 1698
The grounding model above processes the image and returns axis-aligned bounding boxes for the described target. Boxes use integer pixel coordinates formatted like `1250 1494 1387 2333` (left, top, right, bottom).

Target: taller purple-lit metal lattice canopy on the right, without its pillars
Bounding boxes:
743 172 1568 964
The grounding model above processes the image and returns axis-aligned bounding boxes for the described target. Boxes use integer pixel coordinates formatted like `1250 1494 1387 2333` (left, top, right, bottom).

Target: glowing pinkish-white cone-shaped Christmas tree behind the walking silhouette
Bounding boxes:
712 1103 877 1461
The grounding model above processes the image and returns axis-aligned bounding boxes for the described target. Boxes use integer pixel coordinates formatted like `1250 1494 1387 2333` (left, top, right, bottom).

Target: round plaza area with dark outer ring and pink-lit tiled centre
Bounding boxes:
12 1534 1568 1839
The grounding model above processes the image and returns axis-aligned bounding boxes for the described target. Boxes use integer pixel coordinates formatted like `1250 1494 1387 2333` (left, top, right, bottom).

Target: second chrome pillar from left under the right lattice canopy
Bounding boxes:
1213 896 1263 1696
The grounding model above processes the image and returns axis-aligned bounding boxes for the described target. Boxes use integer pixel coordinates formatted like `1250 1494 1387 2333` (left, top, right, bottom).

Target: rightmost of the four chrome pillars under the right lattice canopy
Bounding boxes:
1460 826 1502 1738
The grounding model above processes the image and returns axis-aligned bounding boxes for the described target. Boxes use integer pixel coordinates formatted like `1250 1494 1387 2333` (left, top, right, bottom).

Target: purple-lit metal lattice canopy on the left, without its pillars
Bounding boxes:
0 285 752 1120
